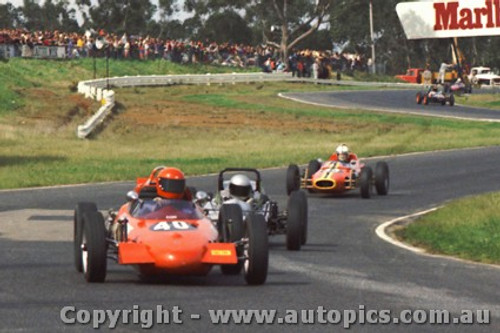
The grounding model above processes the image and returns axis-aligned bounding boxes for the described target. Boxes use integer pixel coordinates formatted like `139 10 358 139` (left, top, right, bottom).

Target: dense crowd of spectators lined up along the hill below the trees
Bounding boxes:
0 29 367 78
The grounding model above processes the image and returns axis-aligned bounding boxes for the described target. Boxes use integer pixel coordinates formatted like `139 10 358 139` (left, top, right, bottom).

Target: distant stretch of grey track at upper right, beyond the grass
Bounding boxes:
282 89 500 122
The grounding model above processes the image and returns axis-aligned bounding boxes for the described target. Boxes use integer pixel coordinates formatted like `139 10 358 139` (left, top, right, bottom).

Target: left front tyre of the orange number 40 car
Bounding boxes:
81 211 107 282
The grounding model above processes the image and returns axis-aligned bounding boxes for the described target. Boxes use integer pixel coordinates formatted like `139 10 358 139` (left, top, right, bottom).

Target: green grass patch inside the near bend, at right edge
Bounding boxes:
395 193 500 264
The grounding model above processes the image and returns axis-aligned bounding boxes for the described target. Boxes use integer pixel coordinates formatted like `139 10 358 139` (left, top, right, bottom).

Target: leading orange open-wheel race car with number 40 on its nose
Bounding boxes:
74 167 269 285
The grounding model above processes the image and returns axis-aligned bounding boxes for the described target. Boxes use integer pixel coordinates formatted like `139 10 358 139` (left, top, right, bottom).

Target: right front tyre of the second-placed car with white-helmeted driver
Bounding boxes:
286 191 307 251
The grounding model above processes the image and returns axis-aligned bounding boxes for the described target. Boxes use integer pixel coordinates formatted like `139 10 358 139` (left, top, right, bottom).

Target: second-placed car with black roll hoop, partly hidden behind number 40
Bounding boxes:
196 168 308 250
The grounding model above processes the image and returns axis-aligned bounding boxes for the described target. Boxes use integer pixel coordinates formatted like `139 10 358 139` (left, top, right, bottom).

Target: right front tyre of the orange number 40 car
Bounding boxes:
243 212 269 285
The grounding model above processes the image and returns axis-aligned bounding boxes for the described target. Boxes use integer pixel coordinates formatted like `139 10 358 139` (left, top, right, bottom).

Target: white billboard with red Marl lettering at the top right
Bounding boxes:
396 0 500 39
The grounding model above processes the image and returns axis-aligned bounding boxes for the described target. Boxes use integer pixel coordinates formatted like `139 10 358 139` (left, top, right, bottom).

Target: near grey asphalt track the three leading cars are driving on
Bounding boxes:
0 92 500 332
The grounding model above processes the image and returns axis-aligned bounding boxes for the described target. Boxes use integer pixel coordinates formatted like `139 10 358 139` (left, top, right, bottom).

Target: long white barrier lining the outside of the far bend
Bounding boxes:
77 73 420 138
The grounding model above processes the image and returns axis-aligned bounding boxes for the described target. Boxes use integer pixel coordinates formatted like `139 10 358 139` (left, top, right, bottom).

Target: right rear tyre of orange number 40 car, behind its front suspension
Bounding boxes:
219 204 245 275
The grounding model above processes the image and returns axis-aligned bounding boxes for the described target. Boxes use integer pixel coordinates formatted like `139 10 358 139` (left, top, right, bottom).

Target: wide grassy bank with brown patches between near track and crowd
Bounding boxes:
0 59 500 189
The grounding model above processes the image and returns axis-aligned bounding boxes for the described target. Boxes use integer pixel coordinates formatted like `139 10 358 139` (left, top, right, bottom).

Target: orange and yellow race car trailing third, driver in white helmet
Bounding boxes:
286 144 389 198
